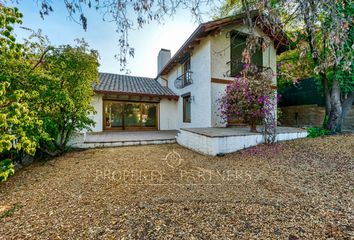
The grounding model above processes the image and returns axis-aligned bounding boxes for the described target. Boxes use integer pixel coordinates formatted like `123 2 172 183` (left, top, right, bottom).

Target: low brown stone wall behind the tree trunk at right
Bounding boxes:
279 105 354 130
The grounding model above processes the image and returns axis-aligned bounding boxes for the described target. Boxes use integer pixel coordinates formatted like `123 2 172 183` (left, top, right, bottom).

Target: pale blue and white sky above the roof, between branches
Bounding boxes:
11 0 214 77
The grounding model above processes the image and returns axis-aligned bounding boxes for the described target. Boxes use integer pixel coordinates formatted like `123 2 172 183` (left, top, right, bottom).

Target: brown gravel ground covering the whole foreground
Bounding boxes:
0 135 354 240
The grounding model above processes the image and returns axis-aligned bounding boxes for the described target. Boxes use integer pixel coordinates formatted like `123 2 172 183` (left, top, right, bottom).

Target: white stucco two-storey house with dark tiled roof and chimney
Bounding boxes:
92 12 288 135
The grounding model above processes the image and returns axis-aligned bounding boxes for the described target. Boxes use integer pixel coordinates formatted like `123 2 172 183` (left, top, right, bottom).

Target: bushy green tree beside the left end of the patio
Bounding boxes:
33 40 99 152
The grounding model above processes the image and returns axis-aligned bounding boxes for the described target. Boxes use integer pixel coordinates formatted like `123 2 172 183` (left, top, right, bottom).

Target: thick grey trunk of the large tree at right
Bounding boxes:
327 77 342 133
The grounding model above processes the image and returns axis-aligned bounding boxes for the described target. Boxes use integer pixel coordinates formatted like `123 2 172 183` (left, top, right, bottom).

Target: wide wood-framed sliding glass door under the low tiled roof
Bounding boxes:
103 101 158 130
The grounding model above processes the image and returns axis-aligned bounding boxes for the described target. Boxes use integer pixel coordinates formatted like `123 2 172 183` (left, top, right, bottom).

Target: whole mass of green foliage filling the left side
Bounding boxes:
0 4 98 181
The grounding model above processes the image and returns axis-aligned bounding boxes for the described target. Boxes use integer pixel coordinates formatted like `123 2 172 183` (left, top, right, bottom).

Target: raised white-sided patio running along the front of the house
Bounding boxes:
70 127 307 153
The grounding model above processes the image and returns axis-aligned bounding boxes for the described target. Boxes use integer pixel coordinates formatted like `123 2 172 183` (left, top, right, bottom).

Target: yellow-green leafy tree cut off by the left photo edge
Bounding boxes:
0 4 45 182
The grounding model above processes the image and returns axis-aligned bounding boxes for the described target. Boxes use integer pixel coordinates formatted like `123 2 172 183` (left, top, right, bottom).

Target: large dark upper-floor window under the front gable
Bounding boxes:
230 31 263 77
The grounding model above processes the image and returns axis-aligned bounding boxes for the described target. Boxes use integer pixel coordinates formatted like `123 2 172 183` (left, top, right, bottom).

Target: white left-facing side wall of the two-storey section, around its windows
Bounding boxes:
161 37 211 128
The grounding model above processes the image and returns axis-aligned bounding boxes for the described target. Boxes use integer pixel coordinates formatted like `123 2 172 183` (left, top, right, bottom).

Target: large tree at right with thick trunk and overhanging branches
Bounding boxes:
216 0 354 132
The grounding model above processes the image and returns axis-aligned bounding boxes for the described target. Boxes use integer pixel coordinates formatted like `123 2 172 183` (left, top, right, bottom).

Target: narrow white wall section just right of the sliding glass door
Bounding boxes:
159 99 178 130
